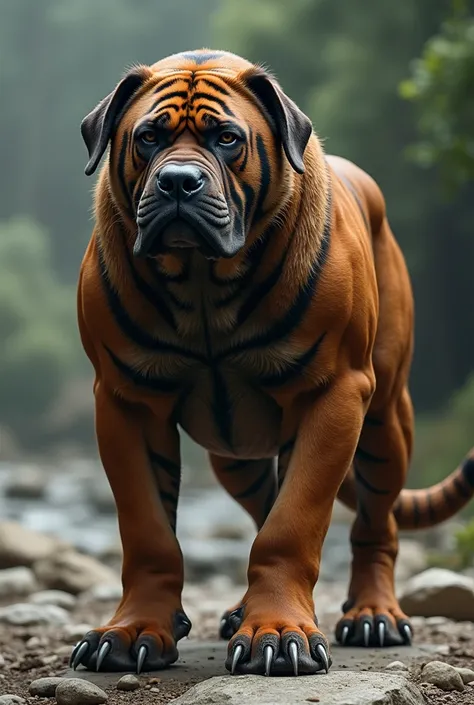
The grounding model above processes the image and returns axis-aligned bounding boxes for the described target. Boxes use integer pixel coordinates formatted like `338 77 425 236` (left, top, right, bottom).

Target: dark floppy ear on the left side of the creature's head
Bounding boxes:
81 66 150 176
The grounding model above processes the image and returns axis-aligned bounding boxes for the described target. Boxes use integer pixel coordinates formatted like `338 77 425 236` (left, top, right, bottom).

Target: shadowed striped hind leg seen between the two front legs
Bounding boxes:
209 455 278 639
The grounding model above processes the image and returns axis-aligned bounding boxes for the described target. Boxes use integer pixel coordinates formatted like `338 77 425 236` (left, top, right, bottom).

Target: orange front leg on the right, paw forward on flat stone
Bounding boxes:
226 372 373 675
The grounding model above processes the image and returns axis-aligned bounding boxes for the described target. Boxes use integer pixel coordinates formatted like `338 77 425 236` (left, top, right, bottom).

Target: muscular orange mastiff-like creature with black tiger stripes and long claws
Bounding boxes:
72 50 474 675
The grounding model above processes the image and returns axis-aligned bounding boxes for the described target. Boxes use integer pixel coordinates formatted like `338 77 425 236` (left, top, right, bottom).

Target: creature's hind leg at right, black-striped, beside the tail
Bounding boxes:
336 389 413 646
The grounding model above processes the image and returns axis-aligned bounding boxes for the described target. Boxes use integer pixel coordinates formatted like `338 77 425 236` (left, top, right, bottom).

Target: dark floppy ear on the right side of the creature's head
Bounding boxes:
244 68 313 174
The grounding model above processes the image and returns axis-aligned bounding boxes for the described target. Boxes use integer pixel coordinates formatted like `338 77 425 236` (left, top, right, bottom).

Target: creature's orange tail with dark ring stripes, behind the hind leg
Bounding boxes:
337 448 474 530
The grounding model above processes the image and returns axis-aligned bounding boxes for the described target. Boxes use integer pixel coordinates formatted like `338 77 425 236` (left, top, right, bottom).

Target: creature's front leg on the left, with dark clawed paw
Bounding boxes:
71 382 191 672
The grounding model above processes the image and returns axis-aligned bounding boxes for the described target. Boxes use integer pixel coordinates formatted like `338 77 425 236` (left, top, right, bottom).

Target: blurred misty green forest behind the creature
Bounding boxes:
0 0 474 496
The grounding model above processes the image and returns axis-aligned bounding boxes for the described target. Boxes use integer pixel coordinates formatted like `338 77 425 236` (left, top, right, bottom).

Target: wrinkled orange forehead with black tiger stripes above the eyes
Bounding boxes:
122 52 259 127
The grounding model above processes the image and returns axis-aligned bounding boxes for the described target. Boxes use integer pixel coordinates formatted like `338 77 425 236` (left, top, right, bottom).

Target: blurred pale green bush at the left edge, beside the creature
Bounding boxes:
0 217 83 440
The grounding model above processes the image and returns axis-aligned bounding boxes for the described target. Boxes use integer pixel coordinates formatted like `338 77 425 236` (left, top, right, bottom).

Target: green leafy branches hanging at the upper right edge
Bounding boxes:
400 0 474 193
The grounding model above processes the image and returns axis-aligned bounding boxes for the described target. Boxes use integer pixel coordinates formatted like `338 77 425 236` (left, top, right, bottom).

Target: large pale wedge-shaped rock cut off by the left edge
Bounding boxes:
0 521 66 568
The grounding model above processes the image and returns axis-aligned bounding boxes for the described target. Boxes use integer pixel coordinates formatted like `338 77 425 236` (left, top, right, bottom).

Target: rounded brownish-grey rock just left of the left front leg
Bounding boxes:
33 549 117 595
